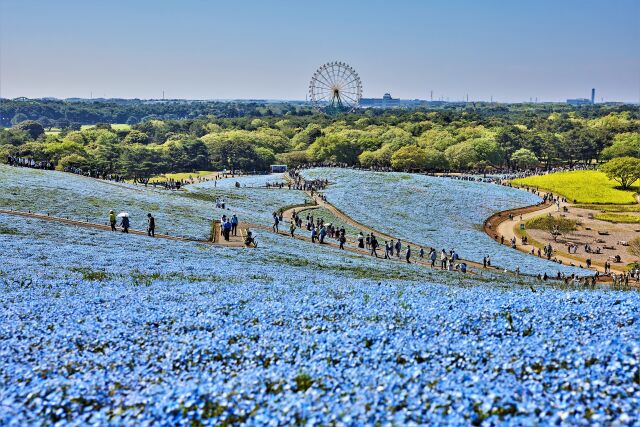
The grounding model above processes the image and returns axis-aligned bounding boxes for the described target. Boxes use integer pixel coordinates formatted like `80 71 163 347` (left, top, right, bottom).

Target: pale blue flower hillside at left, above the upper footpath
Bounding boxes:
0 164 305 239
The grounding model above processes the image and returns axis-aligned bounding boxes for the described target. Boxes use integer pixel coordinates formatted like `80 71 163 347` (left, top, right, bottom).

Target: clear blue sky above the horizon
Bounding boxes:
0 0 640 102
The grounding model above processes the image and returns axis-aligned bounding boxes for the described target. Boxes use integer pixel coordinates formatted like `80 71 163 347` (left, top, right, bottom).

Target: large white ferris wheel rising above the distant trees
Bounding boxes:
309 61 362 113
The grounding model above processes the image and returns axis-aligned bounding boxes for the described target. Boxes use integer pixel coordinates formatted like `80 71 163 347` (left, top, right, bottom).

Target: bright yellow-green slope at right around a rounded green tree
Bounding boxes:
512 171 638 204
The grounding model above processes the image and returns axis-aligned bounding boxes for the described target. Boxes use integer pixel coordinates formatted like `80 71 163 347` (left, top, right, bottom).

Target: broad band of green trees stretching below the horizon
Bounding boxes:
0 103 640 178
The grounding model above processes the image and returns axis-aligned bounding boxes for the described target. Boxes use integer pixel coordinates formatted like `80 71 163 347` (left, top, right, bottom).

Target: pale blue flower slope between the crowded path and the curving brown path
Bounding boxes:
304 168 588 275
